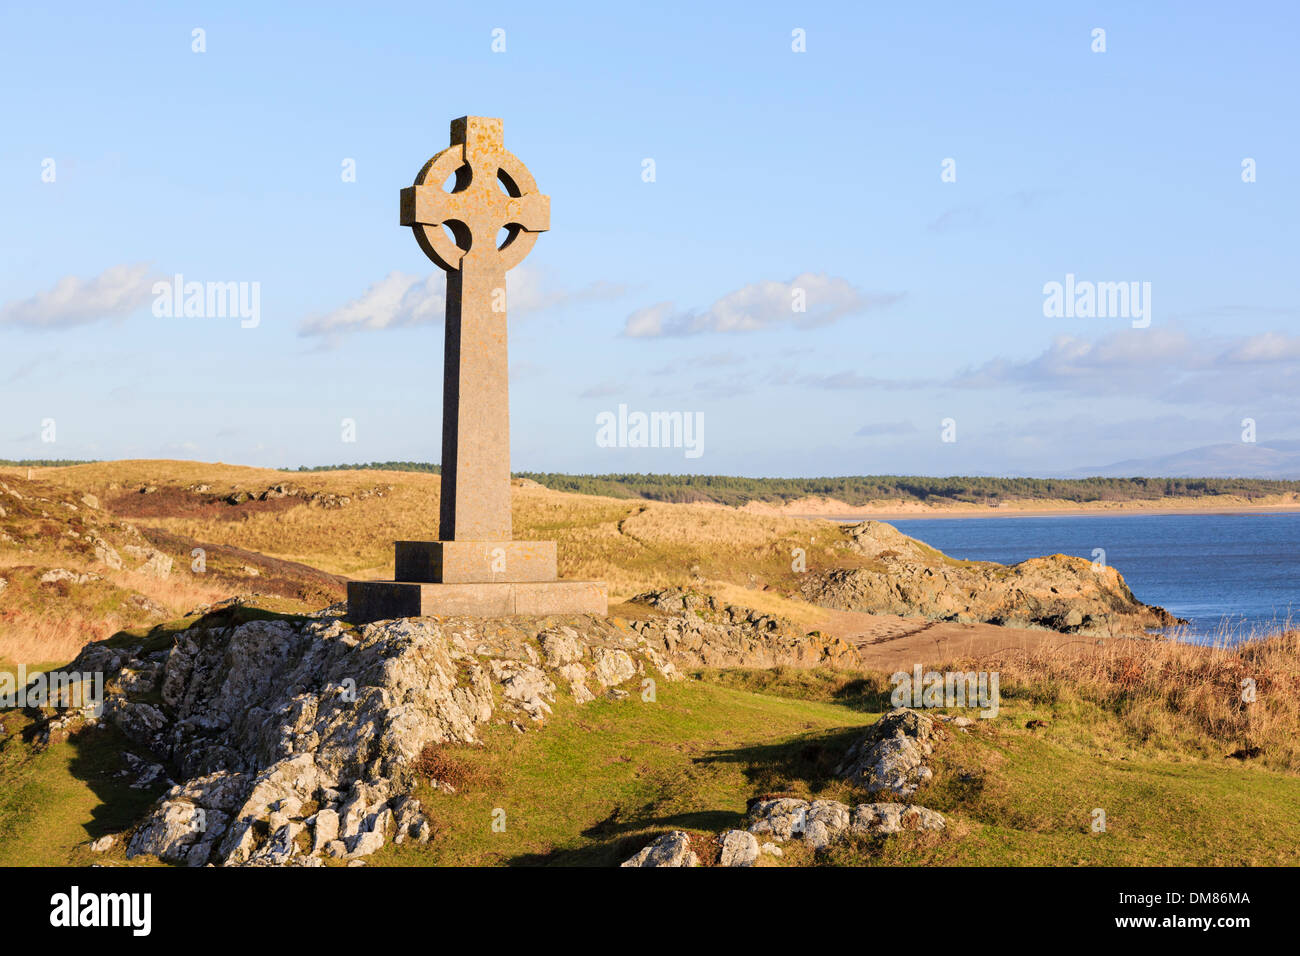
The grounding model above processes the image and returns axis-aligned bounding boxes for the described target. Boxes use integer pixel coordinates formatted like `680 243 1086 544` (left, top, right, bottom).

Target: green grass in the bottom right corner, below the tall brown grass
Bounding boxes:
894 723 1300 866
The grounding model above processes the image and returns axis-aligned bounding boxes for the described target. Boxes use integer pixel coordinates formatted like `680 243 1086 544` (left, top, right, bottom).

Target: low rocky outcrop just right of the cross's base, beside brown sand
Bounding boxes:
631 588 859 667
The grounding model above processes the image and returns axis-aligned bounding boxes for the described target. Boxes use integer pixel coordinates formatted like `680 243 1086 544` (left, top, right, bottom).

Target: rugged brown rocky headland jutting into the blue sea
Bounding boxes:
800 522 1186 636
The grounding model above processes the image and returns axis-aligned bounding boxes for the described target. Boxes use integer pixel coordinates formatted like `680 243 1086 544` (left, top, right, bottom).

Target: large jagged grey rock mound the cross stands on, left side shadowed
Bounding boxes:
69 617 677 866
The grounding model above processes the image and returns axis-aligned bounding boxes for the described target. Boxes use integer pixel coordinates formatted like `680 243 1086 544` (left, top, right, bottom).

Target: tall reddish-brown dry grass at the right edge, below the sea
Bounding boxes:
941 631 1300 771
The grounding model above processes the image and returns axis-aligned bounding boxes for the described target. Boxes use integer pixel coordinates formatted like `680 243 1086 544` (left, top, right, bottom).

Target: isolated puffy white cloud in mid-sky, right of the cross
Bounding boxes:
623 272 902 338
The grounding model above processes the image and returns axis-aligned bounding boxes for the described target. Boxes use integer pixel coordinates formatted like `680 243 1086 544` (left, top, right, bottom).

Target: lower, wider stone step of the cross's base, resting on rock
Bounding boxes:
347 581 610 624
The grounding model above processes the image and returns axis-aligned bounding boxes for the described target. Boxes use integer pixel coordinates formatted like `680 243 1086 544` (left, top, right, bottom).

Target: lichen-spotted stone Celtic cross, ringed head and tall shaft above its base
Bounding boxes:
402 116 551 541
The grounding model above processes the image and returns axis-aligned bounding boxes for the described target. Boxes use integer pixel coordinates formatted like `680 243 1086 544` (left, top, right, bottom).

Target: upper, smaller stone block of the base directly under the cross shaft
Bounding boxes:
395 541 555 584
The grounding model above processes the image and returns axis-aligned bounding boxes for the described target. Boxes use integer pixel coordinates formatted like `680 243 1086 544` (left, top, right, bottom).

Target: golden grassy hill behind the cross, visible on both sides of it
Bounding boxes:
0 460 858 658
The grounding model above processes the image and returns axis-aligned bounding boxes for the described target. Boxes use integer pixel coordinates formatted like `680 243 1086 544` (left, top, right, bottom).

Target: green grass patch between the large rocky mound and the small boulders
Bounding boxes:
374 682 871 866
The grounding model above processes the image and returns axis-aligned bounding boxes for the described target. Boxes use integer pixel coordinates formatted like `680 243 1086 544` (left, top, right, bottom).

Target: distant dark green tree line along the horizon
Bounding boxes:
299 462 1300 505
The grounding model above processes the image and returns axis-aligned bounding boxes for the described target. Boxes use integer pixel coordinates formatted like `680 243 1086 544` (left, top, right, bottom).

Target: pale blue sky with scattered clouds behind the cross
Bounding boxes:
0 3 1300 476
